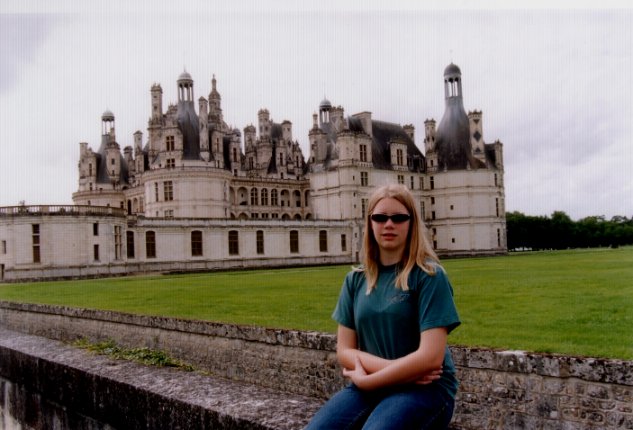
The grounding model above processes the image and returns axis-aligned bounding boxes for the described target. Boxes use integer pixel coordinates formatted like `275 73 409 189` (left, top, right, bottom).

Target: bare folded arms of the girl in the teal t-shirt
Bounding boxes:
336 325 448 390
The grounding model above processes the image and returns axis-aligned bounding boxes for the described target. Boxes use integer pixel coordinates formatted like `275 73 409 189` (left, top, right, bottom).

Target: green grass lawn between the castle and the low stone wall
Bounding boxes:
0 247 633 360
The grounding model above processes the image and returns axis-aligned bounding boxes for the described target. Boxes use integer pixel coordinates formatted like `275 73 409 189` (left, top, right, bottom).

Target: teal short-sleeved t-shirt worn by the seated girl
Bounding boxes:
332 265 460 397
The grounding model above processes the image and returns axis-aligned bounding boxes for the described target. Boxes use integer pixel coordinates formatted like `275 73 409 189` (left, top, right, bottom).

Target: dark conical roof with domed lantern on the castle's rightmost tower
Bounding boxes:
436 63 472 170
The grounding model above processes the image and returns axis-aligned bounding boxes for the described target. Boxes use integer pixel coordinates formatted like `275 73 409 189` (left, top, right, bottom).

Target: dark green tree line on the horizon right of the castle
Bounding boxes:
506 211 633 251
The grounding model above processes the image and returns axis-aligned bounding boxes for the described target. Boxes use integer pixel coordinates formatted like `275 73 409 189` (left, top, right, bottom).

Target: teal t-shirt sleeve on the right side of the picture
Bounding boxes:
418 266 461 333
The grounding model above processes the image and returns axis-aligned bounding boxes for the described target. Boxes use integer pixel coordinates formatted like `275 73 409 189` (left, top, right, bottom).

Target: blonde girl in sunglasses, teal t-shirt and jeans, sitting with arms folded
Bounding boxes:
307 185 460 430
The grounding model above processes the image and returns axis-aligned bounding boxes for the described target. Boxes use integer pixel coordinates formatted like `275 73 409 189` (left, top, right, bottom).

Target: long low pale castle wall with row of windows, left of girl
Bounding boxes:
0 206 358 281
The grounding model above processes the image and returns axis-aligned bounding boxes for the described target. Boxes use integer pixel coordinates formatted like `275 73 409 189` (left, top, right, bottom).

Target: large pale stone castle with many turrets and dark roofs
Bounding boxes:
0 63 507 281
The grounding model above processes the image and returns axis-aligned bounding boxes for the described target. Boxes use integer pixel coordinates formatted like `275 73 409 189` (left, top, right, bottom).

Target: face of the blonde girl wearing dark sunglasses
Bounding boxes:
371 197 411 257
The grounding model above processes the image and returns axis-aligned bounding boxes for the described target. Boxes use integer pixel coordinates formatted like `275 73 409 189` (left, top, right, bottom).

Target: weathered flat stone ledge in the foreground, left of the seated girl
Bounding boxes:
0 327 323 430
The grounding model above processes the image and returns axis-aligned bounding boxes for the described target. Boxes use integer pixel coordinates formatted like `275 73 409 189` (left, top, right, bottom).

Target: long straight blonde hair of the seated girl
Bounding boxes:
356 184 439 294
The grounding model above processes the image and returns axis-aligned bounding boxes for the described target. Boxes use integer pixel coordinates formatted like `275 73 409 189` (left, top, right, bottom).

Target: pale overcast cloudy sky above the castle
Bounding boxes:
0 0 633 219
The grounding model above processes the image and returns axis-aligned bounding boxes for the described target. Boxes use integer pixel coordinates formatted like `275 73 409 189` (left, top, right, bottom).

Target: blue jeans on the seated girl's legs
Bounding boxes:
306 384 455 430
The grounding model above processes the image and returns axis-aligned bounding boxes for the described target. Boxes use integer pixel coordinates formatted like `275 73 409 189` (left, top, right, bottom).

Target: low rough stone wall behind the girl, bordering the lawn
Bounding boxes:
0 302 633 430
